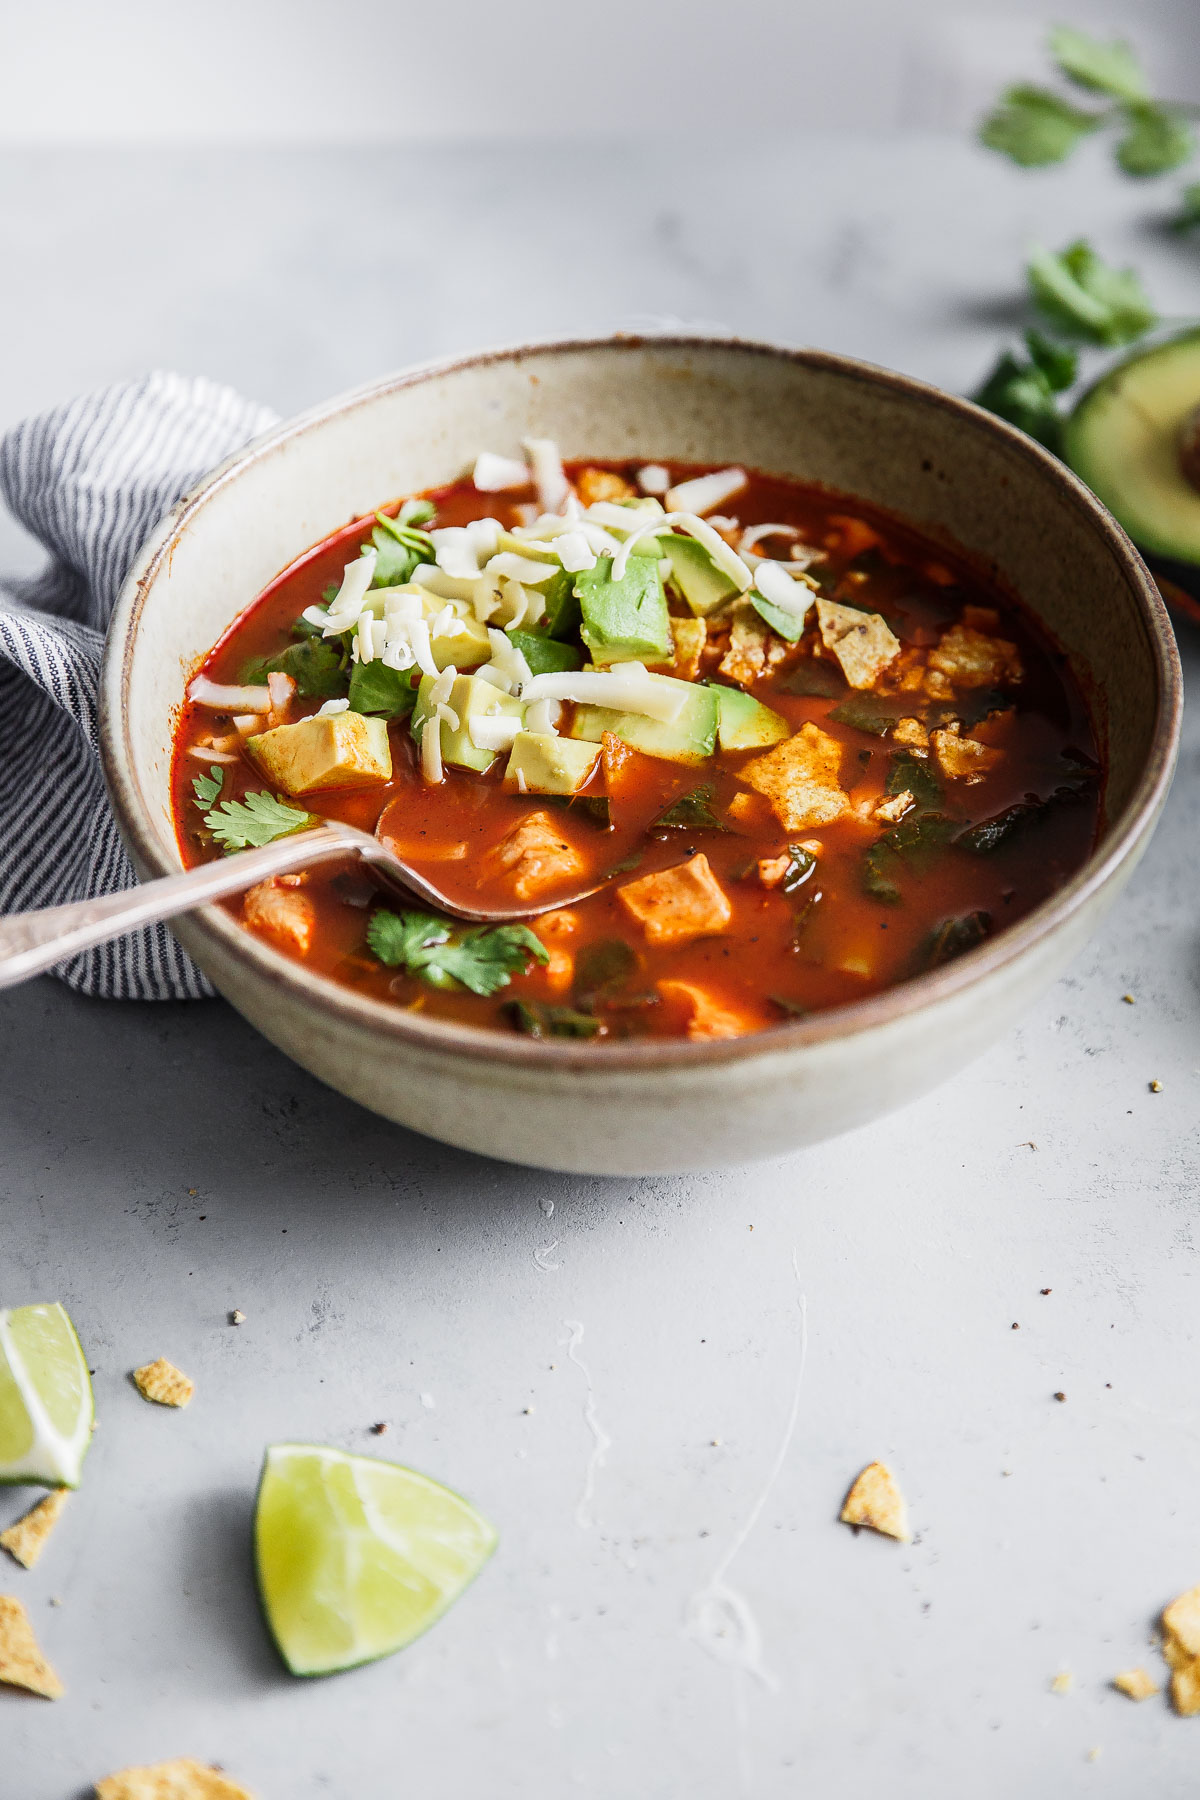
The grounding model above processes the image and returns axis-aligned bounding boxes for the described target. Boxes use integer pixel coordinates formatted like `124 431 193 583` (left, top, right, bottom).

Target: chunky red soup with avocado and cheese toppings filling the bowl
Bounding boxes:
173 439 1101 1040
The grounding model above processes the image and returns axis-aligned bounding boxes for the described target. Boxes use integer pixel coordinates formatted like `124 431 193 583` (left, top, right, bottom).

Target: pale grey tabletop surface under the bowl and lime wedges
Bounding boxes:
0 52 1200 1800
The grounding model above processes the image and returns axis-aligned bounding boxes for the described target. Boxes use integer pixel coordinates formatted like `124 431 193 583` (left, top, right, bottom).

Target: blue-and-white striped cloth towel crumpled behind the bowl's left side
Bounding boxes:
0 374 275 1001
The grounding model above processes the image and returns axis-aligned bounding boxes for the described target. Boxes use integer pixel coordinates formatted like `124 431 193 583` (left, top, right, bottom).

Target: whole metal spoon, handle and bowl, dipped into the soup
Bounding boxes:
0 821 606 988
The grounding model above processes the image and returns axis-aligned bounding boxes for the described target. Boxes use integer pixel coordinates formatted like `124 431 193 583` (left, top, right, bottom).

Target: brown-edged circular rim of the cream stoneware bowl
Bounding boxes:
99 331 1182 1078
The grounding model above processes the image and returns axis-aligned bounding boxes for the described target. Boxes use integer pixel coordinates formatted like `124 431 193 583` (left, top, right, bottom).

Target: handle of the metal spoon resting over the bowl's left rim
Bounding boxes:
0 824 363 988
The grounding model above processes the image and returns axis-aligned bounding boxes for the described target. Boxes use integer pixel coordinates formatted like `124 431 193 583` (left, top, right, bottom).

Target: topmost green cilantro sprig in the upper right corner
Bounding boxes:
979 25 1198 176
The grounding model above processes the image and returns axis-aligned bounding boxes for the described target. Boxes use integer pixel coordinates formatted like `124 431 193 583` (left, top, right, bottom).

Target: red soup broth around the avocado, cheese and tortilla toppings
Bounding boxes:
173 464 1101 1042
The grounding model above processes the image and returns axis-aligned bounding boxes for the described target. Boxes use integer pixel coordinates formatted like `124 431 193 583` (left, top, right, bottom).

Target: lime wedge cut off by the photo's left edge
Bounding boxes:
0 1301 92 1487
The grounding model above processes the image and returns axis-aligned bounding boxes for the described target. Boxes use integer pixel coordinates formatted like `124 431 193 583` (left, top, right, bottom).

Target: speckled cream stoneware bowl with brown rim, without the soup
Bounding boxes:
101 338 1180 1174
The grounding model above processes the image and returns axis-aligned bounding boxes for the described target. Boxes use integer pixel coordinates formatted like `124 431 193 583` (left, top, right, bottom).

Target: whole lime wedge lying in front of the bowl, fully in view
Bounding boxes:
254 1444 497 1676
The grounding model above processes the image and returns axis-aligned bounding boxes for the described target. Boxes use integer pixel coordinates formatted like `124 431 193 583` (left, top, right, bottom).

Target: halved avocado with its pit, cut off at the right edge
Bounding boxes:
1063 328 1200 610
